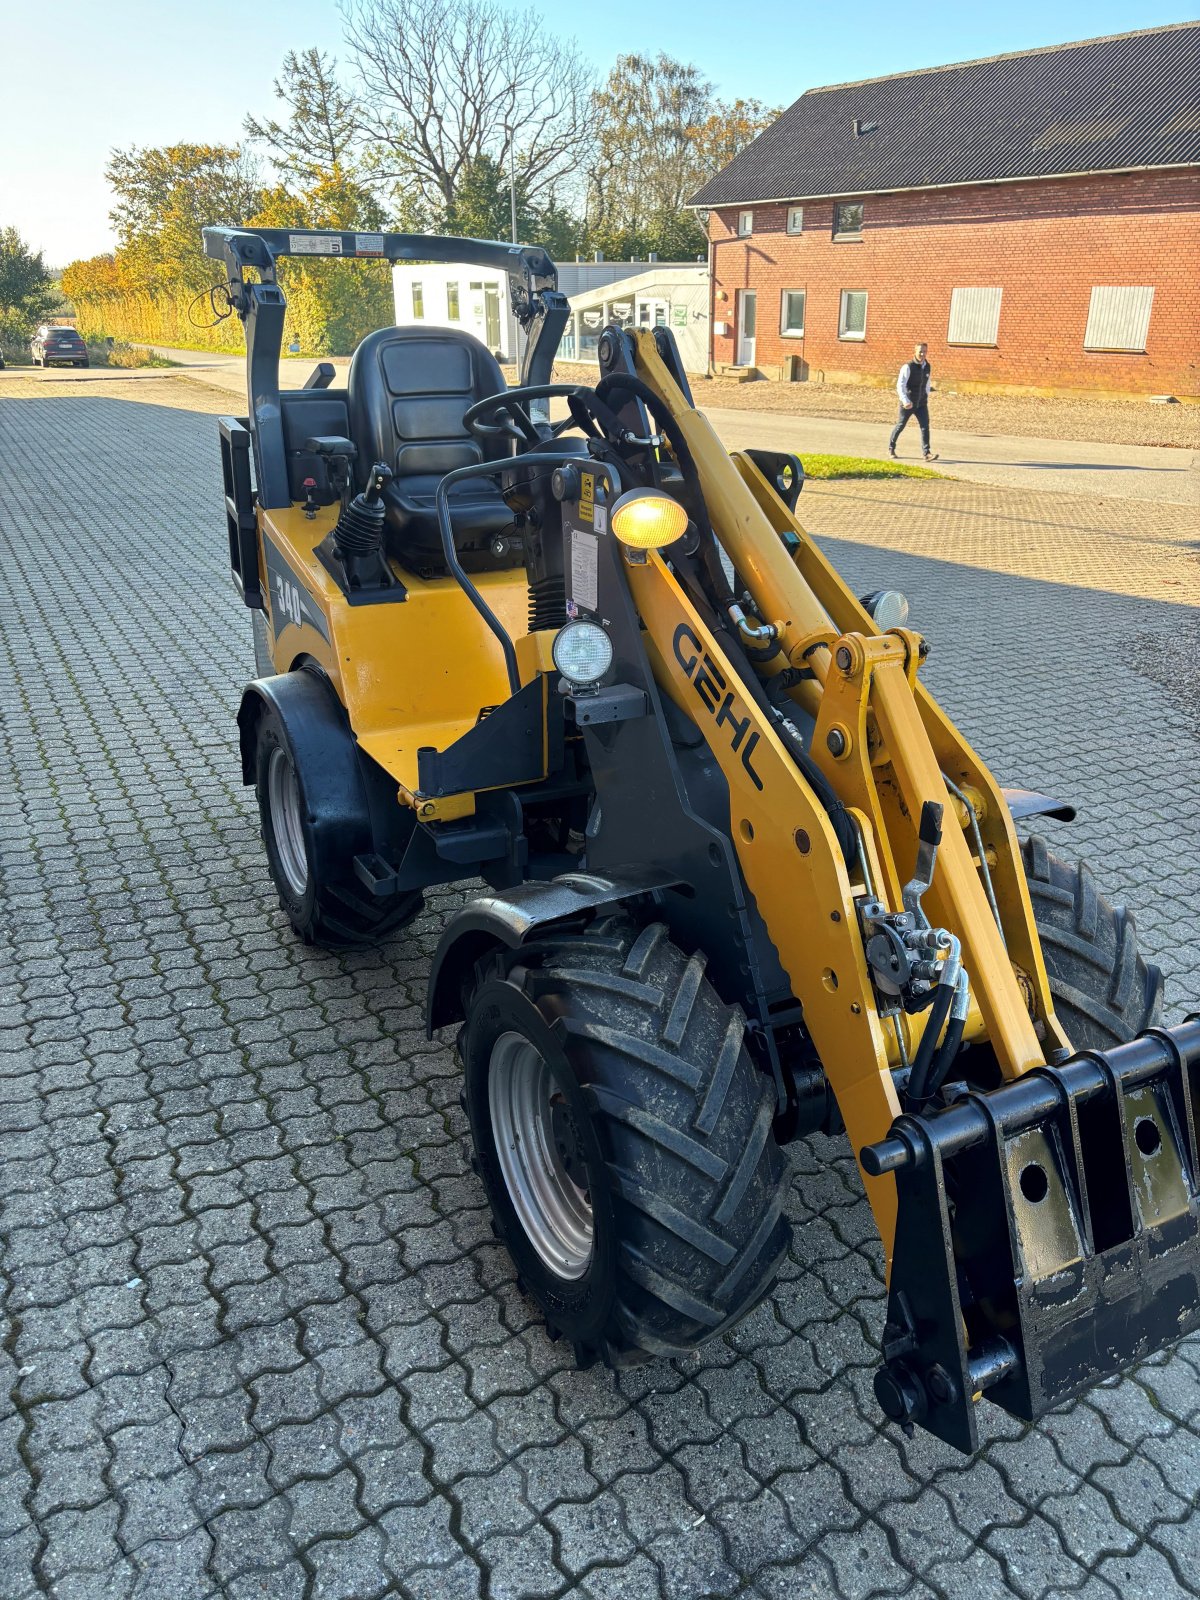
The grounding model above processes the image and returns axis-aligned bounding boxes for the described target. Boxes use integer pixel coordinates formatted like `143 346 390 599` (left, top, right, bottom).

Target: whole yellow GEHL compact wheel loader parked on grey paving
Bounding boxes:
205 229 1200 1450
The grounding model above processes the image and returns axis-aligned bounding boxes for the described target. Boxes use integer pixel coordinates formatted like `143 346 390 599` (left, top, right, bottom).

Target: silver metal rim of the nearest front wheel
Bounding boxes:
488 1034 594 1278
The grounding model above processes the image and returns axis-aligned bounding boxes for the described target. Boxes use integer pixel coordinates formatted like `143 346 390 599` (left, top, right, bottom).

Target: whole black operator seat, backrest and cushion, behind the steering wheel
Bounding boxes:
349 328 523 571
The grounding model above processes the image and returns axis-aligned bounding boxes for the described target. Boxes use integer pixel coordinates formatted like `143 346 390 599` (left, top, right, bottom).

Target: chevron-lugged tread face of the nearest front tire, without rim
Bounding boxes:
464 920 792 1366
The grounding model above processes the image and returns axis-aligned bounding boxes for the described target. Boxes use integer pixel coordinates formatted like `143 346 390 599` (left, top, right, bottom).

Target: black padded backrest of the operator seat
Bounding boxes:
347 326 506 482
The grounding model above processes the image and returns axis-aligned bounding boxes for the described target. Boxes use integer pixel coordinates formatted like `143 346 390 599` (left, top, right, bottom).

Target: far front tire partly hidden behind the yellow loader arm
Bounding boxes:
1021 834 1163 1050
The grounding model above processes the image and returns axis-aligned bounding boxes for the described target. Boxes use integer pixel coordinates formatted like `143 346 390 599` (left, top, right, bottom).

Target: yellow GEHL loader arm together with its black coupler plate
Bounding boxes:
626 334 1200 1451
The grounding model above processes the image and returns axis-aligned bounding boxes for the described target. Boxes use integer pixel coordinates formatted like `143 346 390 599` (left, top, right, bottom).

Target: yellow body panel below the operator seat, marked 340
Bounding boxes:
259 506 539 800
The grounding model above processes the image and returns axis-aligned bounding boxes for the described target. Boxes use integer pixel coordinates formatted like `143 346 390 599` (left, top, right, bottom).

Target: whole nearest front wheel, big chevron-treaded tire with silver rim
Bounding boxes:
459 920 790 1366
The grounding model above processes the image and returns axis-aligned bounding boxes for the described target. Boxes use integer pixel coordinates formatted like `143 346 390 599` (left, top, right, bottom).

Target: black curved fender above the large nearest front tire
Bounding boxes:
426 867 678 1038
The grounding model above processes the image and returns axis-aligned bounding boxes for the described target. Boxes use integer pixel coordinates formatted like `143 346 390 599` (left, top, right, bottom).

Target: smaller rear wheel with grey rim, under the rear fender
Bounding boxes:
254 707 424 950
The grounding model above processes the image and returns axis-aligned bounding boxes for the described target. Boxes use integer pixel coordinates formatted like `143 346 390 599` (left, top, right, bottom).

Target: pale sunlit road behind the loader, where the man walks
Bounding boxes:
91 350 1200 512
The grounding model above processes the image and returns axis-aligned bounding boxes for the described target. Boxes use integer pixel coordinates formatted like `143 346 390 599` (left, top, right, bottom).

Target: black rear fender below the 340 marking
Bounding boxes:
237 669 374 878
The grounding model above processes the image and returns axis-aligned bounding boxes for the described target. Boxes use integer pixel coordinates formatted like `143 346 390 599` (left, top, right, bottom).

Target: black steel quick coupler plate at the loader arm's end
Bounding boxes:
862 1016 1200 1451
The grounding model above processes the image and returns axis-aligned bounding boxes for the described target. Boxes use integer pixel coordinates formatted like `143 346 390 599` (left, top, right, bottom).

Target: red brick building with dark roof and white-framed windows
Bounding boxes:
693 22 1200 395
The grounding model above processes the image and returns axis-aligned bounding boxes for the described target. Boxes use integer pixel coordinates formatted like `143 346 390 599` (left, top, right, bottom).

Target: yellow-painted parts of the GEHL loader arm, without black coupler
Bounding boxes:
629 334 1066 1259
